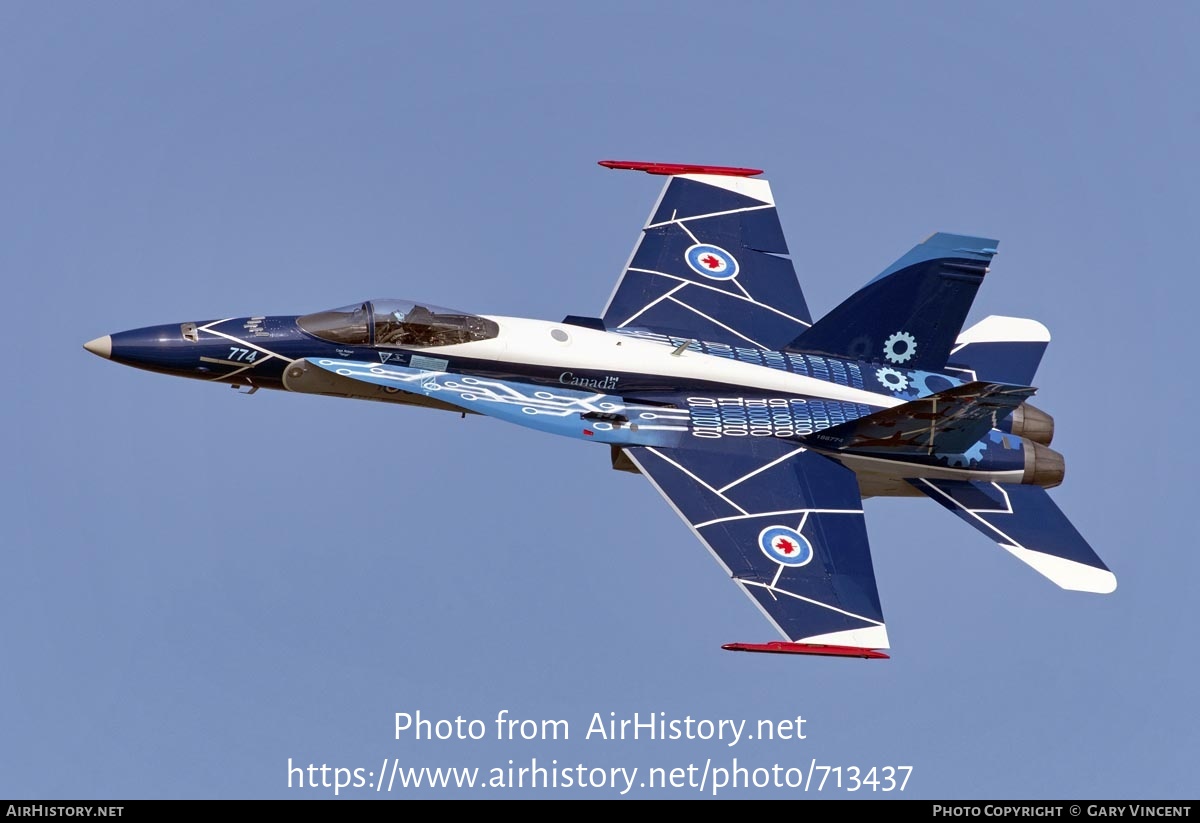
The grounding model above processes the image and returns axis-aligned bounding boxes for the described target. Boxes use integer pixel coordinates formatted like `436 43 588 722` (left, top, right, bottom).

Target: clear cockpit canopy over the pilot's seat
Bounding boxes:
296 300 500 349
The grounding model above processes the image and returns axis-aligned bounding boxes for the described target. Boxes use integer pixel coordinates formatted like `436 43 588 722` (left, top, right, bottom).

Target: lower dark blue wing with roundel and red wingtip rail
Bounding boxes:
625 438 888 657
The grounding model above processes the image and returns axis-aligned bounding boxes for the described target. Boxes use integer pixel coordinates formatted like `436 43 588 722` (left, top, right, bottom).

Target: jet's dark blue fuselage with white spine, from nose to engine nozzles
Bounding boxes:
88 316 1062 495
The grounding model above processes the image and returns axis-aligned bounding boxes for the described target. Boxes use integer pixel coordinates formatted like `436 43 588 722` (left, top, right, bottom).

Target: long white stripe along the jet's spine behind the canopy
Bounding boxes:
410 314 904 408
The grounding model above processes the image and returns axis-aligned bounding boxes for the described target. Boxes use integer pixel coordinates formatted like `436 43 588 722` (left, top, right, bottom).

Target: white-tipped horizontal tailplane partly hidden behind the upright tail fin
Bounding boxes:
947 314 1050 385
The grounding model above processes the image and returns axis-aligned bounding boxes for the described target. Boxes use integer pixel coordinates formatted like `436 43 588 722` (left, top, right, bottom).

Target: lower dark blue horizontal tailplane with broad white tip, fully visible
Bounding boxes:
908 477 1117 594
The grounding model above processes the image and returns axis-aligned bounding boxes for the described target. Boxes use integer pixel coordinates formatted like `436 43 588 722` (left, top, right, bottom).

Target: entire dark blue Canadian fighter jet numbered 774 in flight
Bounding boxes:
85 161 1116 657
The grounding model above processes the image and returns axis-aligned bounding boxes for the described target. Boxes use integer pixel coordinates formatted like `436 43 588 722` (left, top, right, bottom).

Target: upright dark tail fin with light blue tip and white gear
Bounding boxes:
787 233 996 372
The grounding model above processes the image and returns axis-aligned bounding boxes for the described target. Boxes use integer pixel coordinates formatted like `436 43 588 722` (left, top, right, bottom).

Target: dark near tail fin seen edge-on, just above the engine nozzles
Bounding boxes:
804 382 1036 456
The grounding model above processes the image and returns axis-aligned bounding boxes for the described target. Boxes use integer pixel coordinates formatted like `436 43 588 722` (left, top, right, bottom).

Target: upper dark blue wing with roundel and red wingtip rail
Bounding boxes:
600 161 811 349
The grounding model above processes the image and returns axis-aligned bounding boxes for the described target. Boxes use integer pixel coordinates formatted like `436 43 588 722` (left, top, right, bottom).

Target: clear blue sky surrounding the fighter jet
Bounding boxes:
0 2 1200 799
